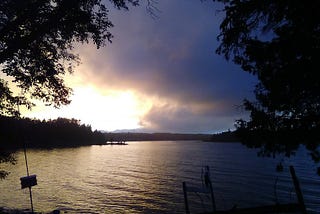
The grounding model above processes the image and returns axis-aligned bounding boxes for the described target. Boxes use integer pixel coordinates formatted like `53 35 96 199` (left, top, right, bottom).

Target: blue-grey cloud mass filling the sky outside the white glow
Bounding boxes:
77 0 255 132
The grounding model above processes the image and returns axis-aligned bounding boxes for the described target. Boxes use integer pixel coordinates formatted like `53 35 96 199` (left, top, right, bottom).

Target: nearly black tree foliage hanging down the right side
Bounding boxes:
217 0 320 161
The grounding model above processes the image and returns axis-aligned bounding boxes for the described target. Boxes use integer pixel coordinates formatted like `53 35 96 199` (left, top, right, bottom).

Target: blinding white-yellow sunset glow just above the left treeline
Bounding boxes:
23 87 150 131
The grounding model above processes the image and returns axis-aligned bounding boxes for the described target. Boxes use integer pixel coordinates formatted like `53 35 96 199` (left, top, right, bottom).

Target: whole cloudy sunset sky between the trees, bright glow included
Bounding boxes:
23 0 256 133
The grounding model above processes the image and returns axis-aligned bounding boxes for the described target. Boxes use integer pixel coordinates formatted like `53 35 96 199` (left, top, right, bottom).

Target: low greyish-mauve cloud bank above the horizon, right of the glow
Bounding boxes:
140 99 242 133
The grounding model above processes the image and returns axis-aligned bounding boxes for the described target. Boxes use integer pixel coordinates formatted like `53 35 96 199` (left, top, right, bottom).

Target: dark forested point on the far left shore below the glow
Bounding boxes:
0 116 105 149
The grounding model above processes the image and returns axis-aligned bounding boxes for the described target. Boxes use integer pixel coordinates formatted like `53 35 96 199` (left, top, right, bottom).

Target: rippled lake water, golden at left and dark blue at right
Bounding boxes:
0 141 320 213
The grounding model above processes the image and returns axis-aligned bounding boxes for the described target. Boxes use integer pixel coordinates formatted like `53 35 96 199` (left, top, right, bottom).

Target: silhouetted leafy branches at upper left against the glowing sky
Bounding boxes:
0 0 138 115
